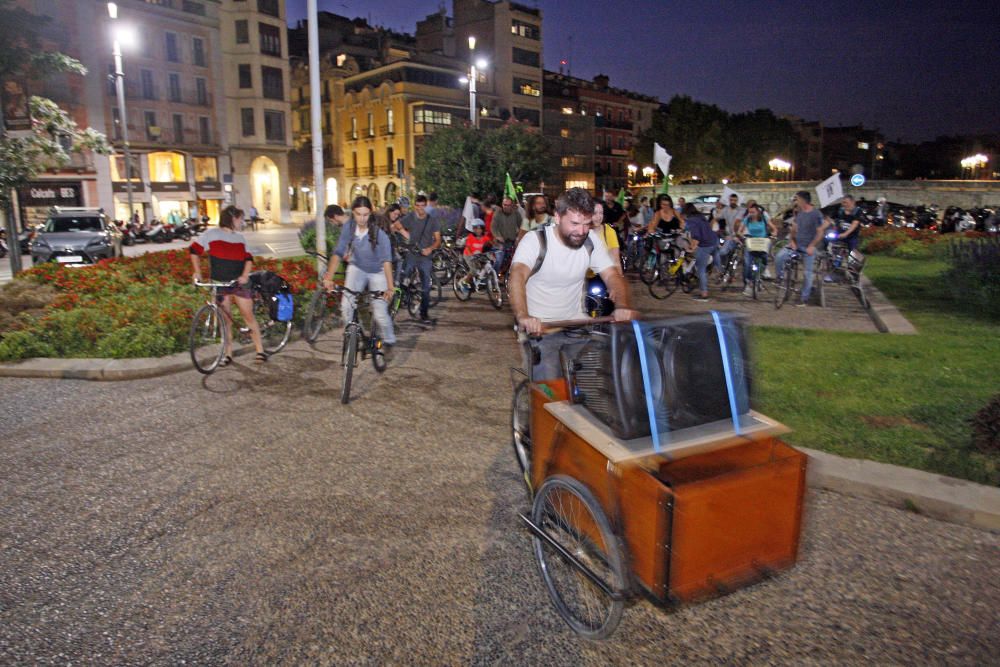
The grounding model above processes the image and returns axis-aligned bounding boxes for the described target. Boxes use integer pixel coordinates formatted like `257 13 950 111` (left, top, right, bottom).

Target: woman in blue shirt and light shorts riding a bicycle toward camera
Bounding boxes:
323 196 396 347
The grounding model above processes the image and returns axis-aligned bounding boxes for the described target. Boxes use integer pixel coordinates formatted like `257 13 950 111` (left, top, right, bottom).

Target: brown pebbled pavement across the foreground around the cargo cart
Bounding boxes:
0 295 1000 665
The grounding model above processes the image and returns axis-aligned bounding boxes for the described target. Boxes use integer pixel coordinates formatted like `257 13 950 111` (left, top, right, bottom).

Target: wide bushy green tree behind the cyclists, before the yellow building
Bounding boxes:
413 121 549 206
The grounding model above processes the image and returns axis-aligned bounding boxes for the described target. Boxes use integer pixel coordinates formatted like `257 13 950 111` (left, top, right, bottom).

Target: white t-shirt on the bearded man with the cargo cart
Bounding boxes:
512 225 614 322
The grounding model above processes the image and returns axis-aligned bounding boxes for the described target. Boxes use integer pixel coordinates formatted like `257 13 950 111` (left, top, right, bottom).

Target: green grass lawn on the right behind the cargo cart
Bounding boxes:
754 256 1000 485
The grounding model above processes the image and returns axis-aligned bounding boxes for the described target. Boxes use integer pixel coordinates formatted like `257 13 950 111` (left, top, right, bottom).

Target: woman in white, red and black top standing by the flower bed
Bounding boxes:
190 206 267 366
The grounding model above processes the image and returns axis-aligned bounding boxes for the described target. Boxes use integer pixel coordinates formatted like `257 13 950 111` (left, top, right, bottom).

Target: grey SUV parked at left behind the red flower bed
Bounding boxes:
31 208 122 264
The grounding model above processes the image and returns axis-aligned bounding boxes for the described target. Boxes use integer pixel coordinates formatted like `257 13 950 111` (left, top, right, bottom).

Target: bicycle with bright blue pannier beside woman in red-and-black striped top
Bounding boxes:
188 280 292 375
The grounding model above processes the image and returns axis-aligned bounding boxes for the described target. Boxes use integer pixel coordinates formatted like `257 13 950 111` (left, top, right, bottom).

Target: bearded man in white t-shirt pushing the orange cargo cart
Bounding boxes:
510 188 638 380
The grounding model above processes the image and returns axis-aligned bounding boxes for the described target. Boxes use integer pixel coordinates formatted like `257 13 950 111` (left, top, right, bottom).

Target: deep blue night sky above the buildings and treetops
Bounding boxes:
287 0 1000 141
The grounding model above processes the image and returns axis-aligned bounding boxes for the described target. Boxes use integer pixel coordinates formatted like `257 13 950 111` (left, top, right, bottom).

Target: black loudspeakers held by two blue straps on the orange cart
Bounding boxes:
563 312 751 440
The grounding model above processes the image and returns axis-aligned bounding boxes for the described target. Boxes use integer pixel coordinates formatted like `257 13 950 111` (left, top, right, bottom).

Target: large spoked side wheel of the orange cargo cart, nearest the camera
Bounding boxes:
531 475 625 639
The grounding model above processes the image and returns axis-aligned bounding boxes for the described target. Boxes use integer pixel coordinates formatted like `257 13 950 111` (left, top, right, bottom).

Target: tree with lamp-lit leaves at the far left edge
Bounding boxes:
0 0 111 270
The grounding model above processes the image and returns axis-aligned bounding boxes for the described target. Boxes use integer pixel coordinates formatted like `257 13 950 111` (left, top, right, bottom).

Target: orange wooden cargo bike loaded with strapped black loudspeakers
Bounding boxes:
512 312 806 639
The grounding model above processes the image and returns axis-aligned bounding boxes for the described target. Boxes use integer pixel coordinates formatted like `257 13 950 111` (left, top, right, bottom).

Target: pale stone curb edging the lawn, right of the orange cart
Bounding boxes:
797 447 1000 533
